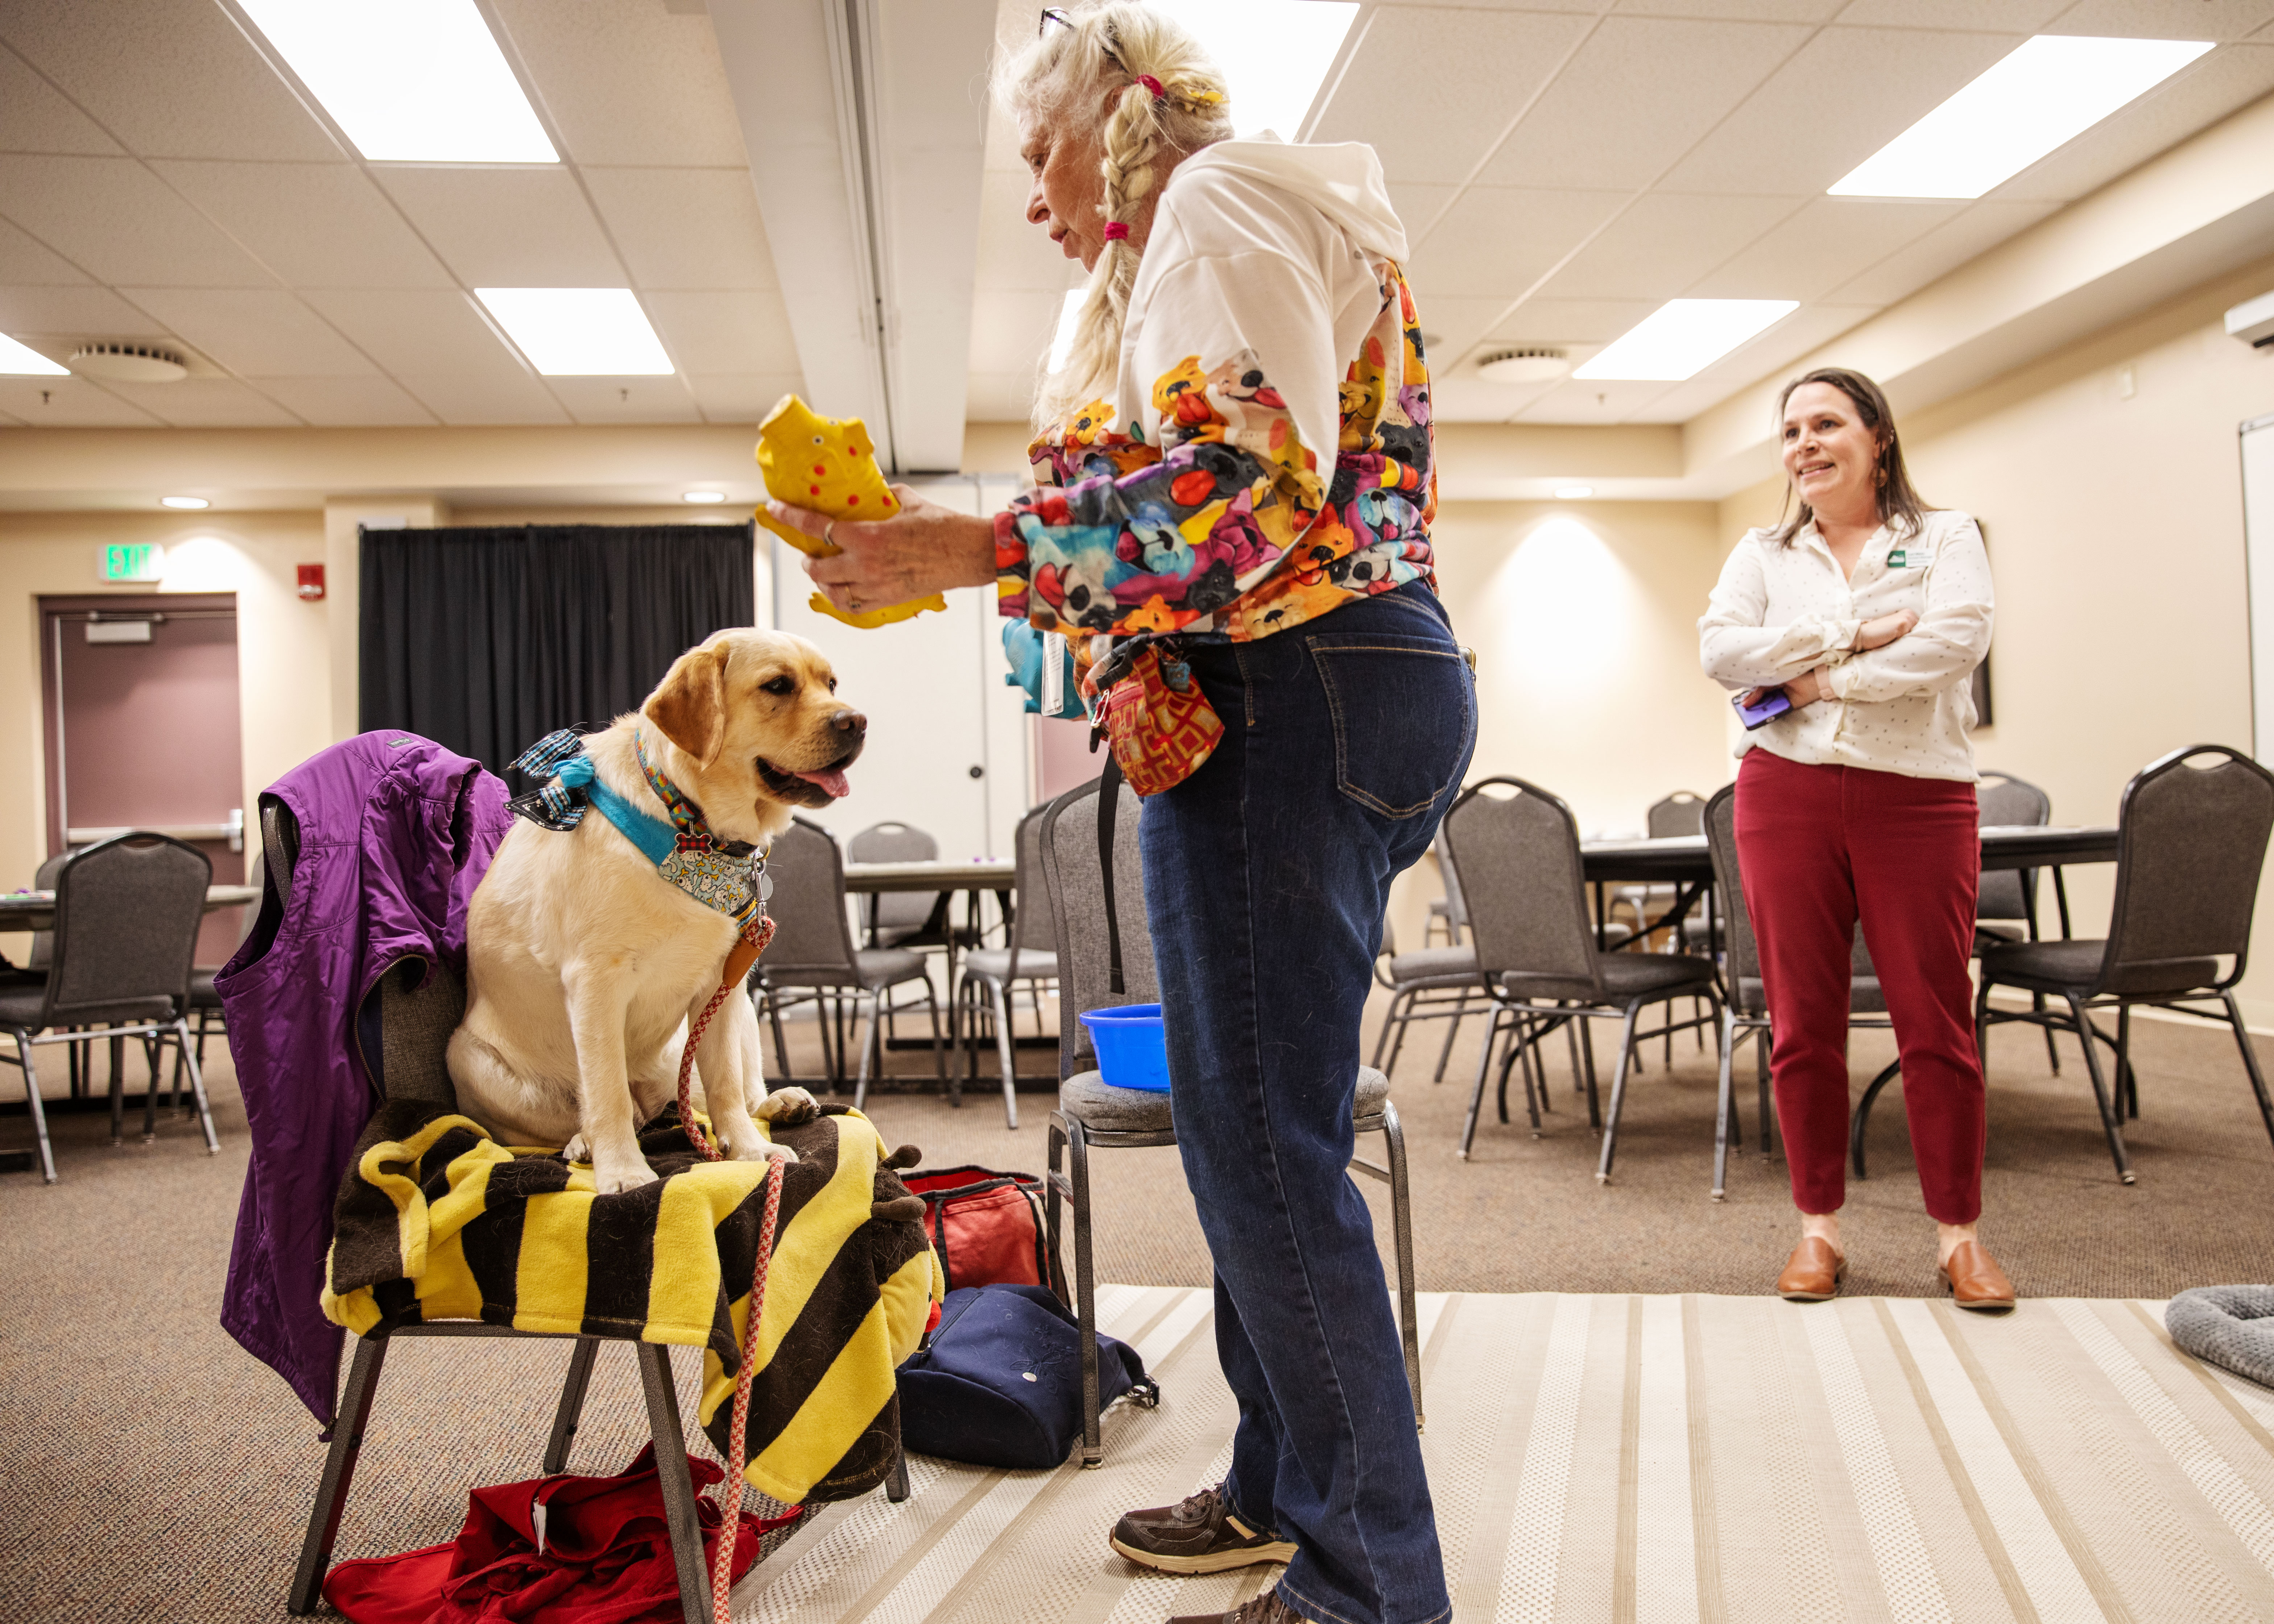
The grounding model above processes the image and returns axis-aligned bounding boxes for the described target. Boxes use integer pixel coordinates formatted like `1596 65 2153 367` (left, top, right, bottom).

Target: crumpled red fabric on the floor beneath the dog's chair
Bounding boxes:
323 1444 798 1624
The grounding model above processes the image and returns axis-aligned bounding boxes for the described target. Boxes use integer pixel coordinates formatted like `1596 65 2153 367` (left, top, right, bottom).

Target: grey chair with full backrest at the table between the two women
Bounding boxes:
1444 778 1721 1183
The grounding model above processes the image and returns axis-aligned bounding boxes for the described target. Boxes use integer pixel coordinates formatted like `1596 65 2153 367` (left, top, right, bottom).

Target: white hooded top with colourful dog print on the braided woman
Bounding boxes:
996 143 1437 666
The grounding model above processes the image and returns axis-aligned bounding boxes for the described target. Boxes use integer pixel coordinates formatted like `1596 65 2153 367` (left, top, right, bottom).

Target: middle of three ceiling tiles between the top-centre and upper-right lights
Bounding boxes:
1478 18 1808 189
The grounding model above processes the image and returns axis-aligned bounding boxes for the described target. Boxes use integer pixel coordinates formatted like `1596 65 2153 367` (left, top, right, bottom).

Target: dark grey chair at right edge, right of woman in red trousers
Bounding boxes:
1974 744 2274 1185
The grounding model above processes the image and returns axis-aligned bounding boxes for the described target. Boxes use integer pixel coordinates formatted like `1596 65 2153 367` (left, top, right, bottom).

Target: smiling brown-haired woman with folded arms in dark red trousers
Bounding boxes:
1699 366 2015 1308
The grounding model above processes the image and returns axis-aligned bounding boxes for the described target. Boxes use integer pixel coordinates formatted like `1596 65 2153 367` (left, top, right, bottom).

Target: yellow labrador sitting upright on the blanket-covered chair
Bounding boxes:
450 630 869 1192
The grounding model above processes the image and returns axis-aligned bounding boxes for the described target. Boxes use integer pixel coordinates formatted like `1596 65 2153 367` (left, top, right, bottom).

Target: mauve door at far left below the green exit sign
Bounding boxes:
38 594 245 964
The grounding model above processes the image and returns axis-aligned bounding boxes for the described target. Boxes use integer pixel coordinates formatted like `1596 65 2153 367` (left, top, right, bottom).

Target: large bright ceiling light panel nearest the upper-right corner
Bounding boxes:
1831 34 2210 198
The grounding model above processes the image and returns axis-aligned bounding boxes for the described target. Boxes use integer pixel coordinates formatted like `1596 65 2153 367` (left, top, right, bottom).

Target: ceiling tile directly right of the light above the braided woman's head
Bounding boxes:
1312 7 1589 182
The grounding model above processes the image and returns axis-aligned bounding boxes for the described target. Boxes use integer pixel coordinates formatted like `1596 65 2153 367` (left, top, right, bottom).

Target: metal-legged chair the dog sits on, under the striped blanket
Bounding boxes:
261 796 907 1624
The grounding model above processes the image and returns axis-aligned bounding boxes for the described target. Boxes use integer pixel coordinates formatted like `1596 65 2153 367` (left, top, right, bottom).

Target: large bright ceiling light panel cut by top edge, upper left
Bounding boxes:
239 0 559 164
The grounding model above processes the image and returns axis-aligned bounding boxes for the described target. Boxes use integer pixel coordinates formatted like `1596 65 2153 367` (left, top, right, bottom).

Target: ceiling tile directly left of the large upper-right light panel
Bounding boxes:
1665 27 2019 198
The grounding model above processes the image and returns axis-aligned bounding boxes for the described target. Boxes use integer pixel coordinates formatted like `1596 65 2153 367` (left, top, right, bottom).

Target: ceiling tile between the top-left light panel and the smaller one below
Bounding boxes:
373 164 625 287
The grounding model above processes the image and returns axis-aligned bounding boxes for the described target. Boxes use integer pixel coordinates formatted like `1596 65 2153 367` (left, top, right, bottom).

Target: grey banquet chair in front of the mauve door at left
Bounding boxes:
0 830 220 1185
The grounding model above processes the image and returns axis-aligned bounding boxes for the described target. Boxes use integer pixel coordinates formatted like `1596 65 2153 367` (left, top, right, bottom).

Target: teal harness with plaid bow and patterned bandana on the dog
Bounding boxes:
507 726 773 930
